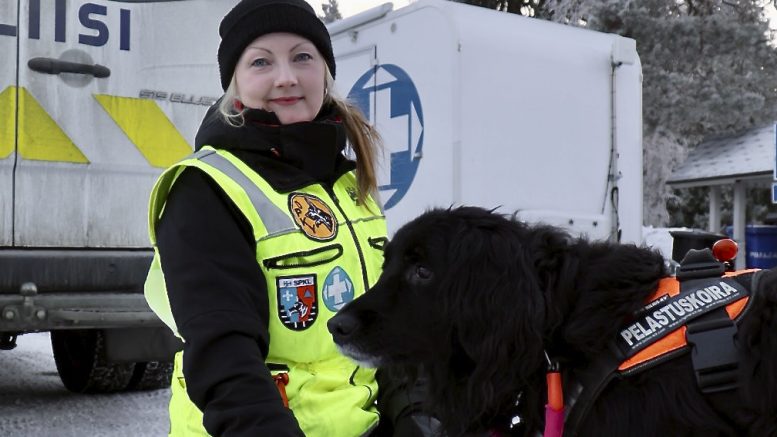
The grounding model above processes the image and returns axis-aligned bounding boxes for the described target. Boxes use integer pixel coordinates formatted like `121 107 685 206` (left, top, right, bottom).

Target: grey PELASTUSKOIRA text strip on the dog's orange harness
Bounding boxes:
616 278 748 357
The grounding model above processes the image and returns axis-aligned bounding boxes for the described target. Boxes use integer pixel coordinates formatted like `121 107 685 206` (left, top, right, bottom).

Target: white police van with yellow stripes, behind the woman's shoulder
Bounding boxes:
0 0 230 392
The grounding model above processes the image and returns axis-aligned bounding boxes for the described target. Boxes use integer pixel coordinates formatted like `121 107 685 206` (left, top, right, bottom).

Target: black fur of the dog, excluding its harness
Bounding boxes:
329 207 777 437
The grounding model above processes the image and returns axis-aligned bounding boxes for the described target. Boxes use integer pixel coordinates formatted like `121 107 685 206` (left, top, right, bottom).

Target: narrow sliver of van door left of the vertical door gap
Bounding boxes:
0 2 18 246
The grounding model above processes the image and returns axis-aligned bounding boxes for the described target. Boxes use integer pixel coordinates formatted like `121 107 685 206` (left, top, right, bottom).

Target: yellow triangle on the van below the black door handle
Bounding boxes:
19 87 89 164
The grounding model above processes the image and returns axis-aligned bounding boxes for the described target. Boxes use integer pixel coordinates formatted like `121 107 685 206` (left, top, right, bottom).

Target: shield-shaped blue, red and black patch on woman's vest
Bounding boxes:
276 275 318 331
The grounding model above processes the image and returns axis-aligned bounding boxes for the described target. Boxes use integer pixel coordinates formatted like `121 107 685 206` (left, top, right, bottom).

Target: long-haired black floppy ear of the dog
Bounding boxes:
439 216 545 430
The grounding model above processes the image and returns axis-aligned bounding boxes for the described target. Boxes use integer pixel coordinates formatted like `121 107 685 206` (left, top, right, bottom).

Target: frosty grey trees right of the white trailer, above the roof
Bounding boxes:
586 0 777 226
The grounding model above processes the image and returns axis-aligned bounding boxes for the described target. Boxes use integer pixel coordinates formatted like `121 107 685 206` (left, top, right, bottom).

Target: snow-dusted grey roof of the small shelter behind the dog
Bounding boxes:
667 125 777 187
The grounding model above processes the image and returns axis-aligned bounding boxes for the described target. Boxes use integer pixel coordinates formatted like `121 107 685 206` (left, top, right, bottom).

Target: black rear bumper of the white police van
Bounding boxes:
0 249 162 333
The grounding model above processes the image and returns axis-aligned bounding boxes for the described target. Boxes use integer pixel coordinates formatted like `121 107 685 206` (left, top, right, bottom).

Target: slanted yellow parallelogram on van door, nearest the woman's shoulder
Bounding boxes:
94 94 192 168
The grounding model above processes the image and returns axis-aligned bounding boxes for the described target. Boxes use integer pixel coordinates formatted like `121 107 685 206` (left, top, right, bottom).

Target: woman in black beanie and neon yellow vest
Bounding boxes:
146 0 422 437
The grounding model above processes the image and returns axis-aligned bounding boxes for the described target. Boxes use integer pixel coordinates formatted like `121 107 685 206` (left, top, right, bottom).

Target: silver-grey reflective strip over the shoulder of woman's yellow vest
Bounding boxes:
192 149 296 235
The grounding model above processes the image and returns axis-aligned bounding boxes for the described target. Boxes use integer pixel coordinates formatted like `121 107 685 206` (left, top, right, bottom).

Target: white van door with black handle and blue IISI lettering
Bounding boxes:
15 0 230 248
